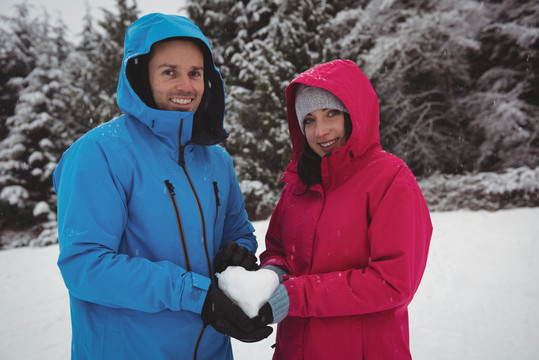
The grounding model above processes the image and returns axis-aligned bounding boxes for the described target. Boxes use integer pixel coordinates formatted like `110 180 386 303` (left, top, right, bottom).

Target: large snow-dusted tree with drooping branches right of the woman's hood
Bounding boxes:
333 0 539 175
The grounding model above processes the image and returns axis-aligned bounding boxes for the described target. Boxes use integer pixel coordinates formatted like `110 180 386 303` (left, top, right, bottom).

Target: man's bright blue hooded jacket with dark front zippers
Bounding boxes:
54 14 257 359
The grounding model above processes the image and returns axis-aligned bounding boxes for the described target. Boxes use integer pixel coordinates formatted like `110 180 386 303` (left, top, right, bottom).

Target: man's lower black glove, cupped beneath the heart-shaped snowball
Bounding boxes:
201 285 273 342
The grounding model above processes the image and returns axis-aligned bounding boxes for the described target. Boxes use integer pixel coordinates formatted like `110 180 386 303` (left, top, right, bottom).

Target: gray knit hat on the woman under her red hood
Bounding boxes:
296 84 348 135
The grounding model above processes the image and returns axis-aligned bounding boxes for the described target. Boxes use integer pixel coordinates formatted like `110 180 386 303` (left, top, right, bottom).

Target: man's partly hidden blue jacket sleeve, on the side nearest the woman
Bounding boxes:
220 156 258 254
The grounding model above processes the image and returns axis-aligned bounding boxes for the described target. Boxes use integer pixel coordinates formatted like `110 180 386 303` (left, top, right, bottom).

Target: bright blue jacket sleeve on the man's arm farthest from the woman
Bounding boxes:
53 138 210 313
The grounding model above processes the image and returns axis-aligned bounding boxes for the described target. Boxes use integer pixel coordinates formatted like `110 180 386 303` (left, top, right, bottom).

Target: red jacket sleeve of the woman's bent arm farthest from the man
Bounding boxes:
284 169 432 317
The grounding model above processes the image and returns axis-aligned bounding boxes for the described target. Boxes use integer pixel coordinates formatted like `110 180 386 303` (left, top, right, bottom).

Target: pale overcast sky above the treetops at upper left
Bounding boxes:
0 0 186 39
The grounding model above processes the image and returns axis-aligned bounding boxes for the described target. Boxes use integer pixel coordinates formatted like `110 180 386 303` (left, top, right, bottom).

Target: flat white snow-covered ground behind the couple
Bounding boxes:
0 208 539 360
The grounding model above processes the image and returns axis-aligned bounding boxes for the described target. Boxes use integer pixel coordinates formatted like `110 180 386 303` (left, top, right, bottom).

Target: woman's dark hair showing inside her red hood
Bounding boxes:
297 112 352 186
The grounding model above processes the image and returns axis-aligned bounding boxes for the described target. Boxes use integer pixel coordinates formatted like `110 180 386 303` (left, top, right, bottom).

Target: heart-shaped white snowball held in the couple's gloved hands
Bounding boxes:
215 266 279 319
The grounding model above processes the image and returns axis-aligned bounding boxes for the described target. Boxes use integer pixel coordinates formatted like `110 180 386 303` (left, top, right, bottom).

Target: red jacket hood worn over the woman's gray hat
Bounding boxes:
286 60 381 172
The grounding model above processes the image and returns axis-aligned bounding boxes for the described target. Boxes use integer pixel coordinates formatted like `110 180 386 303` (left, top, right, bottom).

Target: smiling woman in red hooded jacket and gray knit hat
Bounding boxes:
258 60 432 360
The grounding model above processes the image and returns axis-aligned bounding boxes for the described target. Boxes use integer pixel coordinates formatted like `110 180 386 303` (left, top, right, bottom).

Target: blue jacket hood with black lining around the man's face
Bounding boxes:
116 13 228 145
